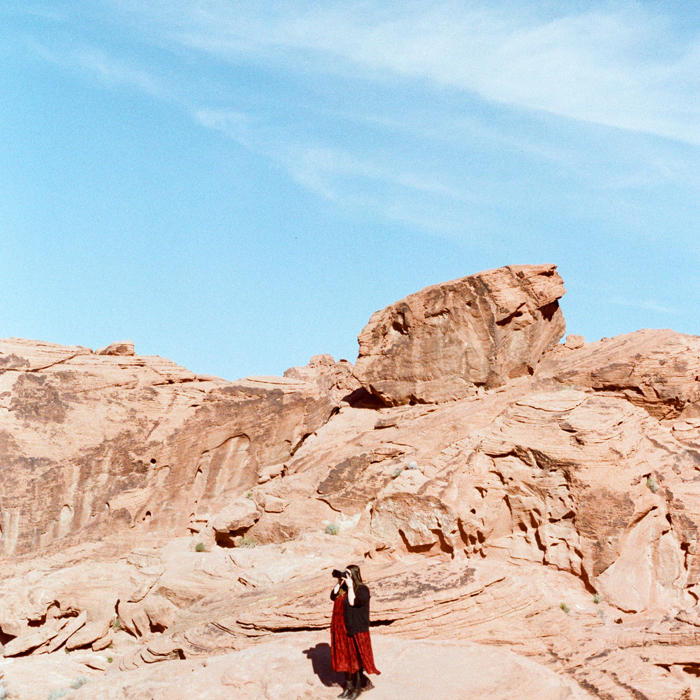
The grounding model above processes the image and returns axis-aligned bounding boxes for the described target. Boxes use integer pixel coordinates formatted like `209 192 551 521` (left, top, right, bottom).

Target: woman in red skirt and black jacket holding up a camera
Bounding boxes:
331 564 379 700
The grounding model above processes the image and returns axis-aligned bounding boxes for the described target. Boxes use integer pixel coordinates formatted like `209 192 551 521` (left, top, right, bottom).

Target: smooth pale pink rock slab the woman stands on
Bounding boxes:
61 633 596 700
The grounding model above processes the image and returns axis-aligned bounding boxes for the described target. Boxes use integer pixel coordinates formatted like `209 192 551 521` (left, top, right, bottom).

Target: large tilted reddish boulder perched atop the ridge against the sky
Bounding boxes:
355 265 566 405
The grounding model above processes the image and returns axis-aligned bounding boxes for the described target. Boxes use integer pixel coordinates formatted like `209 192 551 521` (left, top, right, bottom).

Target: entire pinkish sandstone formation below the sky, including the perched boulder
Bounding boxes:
0 266 700 700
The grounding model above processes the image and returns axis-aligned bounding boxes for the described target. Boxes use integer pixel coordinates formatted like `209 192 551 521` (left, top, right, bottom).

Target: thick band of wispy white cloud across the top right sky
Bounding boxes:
109 0 700 145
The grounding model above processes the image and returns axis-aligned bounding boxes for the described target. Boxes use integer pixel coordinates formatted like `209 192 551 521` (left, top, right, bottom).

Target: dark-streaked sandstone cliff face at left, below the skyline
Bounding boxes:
0 340 334 555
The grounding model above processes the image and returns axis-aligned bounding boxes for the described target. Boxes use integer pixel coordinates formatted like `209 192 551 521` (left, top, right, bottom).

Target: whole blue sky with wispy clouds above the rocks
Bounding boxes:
0 0 700 379
